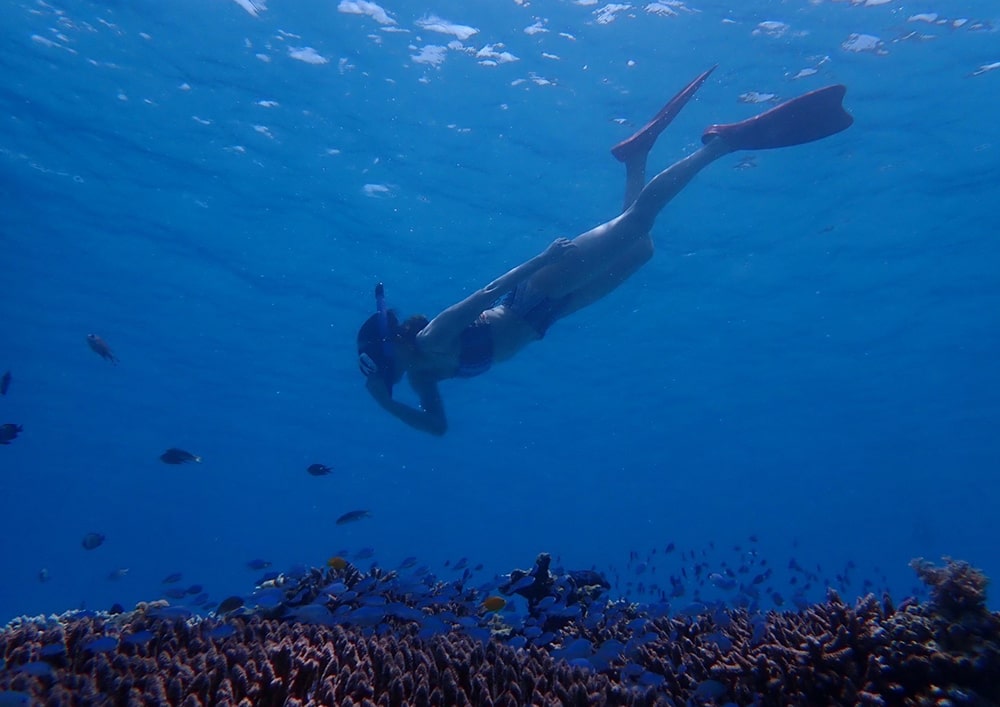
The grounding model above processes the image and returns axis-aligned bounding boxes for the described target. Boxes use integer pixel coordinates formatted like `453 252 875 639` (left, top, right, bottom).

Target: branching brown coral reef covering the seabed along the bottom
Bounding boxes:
0 560 1000 707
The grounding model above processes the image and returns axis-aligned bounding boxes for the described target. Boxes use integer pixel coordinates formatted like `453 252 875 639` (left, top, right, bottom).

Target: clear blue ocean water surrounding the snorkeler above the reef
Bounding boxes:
0 0 1000 620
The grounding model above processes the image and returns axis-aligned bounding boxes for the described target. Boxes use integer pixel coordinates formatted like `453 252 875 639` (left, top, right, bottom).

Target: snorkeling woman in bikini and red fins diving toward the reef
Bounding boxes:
357 67 854 435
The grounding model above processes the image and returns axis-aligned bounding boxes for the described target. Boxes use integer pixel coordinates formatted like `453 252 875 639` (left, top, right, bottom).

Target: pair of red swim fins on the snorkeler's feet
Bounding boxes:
611 66 854 162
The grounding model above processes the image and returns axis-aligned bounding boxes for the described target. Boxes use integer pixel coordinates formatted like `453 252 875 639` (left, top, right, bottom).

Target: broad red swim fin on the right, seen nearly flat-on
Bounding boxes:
701 84 854 150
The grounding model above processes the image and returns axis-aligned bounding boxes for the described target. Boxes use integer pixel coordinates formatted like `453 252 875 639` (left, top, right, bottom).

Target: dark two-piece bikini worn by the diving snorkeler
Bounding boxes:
455 283 566 378
